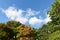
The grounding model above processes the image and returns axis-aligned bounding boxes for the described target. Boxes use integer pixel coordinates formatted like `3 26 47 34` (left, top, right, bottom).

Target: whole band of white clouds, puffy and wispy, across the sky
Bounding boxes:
2 7 51 25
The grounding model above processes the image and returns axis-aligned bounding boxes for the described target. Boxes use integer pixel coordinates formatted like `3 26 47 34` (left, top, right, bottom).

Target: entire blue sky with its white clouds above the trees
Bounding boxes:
0 0 54 28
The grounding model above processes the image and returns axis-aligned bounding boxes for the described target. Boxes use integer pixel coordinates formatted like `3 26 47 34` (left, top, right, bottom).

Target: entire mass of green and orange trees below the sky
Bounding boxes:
0 0 60 40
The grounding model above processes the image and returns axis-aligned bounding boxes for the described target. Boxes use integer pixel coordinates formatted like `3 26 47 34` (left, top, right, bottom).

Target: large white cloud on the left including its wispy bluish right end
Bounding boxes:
1 6 40 24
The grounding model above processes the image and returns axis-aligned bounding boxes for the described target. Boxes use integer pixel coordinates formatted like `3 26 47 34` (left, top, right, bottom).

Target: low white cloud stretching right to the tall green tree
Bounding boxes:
29 15 52 25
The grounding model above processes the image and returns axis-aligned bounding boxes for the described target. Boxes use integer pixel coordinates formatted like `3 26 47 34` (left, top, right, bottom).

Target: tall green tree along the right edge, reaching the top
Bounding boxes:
48 0 60 40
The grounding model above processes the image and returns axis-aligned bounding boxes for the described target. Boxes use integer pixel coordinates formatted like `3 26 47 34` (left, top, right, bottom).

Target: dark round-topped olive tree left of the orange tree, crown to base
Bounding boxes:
6 20 22 40
